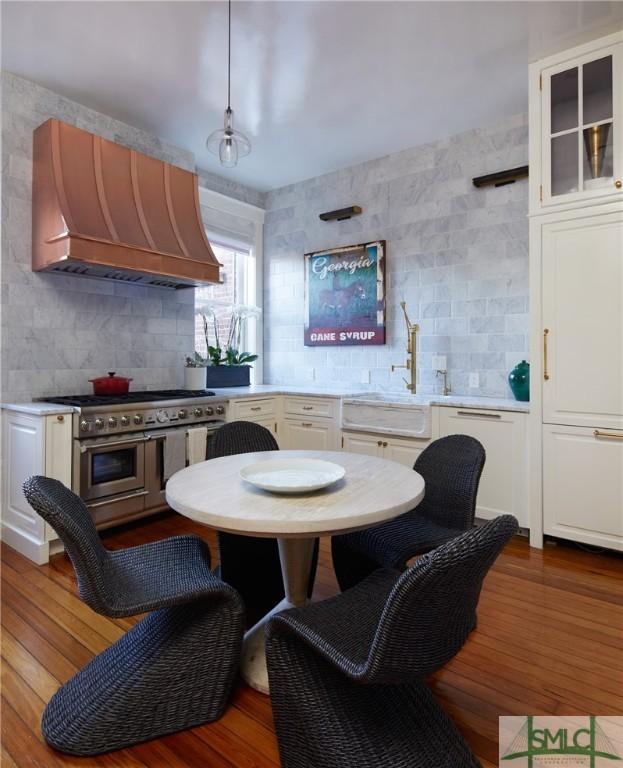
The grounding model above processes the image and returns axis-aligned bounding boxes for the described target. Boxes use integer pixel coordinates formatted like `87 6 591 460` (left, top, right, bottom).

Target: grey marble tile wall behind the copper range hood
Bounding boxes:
1 72 259 402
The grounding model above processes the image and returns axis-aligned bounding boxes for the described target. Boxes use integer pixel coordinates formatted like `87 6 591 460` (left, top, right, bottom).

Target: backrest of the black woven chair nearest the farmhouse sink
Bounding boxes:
413 435 485 531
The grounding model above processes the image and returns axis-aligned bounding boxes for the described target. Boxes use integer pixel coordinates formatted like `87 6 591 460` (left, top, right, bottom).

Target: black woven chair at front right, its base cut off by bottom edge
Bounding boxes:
266 515 517 768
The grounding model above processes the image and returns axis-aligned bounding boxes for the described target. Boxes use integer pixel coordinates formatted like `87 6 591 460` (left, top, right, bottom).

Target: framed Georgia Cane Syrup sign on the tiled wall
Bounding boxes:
305 240 385 347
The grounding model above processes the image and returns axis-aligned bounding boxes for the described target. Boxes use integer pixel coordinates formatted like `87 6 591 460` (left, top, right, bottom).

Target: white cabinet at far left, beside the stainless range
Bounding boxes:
2 410 72 564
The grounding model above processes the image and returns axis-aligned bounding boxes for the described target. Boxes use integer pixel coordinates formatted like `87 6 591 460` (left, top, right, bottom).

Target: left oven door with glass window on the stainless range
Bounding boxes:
79 433 149 502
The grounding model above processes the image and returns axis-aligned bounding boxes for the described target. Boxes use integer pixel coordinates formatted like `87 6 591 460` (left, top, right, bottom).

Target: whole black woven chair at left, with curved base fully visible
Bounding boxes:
24 476 244 755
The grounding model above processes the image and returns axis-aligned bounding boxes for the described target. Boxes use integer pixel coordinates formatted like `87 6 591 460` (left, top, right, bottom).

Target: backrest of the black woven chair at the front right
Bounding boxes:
362 515 518 683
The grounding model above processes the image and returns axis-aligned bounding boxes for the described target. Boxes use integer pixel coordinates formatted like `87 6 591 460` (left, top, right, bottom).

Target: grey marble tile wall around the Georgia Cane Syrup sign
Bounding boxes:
264 114 528 397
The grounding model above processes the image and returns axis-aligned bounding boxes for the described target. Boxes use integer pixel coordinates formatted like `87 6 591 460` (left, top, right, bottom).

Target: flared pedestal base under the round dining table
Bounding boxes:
240 538 316 694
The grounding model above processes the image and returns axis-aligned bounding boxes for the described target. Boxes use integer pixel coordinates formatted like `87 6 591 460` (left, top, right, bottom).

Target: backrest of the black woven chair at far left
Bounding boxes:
23 475 108 613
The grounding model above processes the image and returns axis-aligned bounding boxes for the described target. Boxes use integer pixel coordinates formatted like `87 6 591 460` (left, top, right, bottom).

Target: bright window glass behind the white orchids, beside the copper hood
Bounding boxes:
195 240 255 357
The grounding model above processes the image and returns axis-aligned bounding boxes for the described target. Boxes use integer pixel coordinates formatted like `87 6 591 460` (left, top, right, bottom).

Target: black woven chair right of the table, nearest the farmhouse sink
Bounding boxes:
331 435 485 590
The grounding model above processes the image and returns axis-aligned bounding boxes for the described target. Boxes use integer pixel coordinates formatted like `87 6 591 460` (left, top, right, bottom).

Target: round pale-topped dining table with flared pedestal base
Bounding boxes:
166 451 424 693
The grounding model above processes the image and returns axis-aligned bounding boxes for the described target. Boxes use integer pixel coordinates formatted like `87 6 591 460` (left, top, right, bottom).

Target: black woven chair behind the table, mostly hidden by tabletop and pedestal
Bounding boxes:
208 421 318 626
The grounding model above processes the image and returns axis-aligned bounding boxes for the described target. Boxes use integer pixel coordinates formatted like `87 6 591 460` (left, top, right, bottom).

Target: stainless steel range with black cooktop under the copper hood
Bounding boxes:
45 389 227 528
